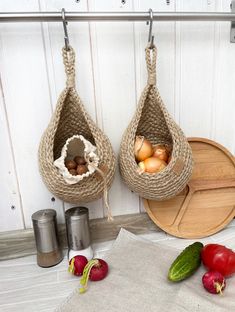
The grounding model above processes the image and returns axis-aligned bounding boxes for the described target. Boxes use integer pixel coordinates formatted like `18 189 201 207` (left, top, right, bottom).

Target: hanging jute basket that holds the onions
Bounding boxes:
119 45 193 200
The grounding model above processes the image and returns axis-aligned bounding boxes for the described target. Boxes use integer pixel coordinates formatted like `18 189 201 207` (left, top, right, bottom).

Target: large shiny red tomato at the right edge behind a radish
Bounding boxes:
201 244 235 277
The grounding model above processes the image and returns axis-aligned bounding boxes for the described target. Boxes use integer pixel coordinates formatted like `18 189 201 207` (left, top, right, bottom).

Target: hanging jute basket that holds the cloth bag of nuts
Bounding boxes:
39 46 115 219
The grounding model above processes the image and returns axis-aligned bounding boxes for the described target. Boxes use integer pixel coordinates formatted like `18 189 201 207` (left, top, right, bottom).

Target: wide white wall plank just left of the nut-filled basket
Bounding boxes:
0 0 62 227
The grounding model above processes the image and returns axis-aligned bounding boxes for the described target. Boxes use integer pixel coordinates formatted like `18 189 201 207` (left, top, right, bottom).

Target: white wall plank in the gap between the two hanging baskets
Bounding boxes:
88 0 139 215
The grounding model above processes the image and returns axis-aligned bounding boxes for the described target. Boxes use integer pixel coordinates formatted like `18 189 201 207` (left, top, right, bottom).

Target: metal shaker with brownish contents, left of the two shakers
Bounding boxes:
32 209 63 267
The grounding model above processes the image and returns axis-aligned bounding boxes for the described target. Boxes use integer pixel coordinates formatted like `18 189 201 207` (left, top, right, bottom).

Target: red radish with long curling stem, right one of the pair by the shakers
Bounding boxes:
79 259 109 293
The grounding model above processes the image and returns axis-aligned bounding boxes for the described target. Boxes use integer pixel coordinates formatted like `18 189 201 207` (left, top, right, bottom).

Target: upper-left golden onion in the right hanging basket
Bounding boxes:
134 135 153 161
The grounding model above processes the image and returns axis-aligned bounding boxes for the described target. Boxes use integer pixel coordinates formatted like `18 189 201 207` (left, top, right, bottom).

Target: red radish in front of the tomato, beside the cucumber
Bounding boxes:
202 271 226 294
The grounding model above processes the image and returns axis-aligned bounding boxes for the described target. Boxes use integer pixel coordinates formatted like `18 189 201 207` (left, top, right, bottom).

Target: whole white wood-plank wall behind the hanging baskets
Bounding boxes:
0 0 235 232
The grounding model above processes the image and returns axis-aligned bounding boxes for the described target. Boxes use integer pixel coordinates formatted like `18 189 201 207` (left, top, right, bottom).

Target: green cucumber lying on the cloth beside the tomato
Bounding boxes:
168 242 203 282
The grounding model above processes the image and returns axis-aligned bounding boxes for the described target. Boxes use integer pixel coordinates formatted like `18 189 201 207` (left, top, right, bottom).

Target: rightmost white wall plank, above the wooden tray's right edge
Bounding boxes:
211 0 235 153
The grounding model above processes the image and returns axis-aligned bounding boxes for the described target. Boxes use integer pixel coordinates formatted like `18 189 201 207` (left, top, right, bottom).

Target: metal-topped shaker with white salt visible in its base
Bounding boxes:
65 206 93 260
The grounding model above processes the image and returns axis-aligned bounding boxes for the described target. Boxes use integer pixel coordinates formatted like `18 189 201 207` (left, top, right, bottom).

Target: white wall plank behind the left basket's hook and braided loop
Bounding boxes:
40 0 103 219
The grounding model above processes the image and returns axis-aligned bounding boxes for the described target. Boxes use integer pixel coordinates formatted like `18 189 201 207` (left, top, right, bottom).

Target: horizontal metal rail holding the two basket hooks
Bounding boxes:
0 12 235 22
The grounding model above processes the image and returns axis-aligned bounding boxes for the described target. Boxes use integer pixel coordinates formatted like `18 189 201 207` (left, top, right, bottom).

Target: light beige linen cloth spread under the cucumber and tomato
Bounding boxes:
56 229 235 312
